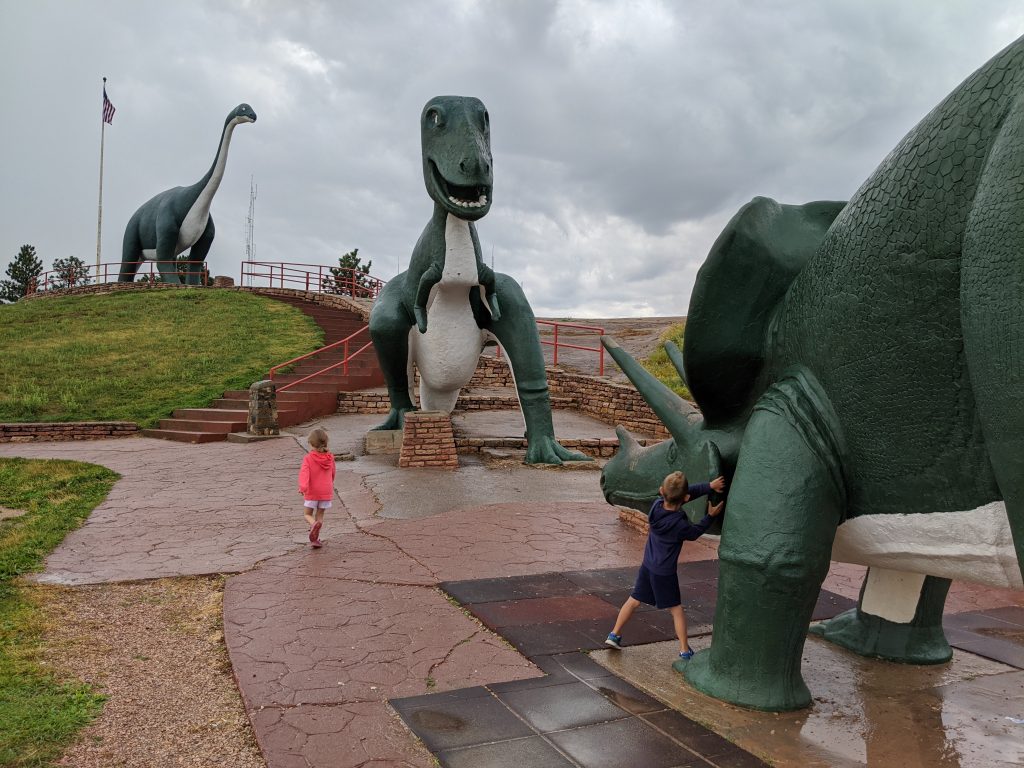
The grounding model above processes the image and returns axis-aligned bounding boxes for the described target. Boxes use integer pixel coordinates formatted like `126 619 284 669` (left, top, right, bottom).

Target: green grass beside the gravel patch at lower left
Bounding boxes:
0 460 118 768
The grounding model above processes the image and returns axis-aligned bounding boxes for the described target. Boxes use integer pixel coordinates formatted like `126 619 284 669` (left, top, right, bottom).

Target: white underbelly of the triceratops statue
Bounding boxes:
833 502 1024 589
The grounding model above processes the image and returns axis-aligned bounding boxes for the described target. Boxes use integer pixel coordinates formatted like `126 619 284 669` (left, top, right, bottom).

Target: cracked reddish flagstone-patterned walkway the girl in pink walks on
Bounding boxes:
0 412 1022 768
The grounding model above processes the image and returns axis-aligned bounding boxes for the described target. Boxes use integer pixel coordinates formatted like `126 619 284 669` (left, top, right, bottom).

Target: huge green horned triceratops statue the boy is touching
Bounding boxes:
602 38 1024 710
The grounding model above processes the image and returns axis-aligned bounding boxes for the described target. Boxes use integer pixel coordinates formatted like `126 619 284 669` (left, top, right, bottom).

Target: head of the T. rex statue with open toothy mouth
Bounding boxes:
420 96 494 221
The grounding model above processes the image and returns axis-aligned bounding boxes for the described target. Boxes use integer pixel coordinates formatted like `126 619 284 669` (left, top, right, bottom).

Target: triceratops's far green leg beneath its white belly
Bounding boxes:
810 568 952 664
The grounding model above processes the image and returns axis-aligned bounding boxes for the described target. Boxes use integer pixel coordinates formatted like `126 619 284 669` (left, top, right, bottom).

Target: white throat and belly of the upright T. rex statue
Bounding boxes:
410 215 484 412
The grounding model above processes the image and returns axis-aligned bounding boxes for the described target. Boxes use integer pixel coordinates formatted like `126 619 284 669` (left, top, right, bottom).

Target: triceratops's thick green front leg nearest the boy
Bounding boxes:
684 372 845 712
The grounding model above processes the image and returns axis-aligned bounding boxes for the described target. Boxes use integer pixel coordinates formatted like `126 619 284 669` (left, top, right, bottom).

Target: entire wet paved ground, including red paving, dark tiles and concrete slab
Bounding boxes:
0 411 1024 768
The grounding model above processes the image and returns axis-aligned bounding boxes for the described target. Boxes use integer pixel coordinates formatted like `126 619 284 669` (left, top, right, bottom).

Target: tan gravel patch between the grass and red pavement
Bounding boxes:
30 578 266 768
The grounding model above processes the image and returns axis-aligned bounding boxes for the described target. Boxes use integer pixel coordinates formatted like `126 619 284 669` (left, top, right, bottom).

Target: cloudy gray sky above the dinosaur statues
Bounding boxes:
0 0 1024 317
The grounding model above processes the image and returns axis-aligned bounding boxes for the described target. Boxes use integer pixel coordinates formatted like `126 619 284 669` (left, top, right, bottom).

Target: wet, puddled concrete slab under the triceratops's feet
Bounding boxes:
591 636 1024 768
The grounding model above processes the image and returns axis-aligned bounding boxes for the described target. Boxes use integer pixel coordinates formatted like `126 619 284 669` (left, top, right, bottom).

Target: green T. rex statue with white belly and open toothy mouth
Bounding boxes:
370 96 587 464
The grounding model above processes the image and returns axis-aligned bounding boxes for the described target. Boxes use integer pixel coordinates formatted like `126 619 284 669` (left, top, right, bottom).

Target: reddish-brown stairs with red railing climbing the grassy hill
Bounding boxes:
142 296 384 442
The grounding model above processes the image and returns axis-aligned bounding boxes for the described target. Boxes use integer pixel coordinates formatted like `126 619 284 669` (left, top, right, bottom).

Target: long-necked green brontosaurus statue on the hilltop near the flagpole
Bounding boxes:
118 104 256 285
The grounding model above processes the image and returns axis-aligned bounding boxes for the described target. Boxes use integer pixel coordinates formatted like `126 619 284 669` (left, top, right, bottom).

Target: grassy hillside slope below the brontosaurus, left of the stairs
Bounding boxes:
0 289 324 427
